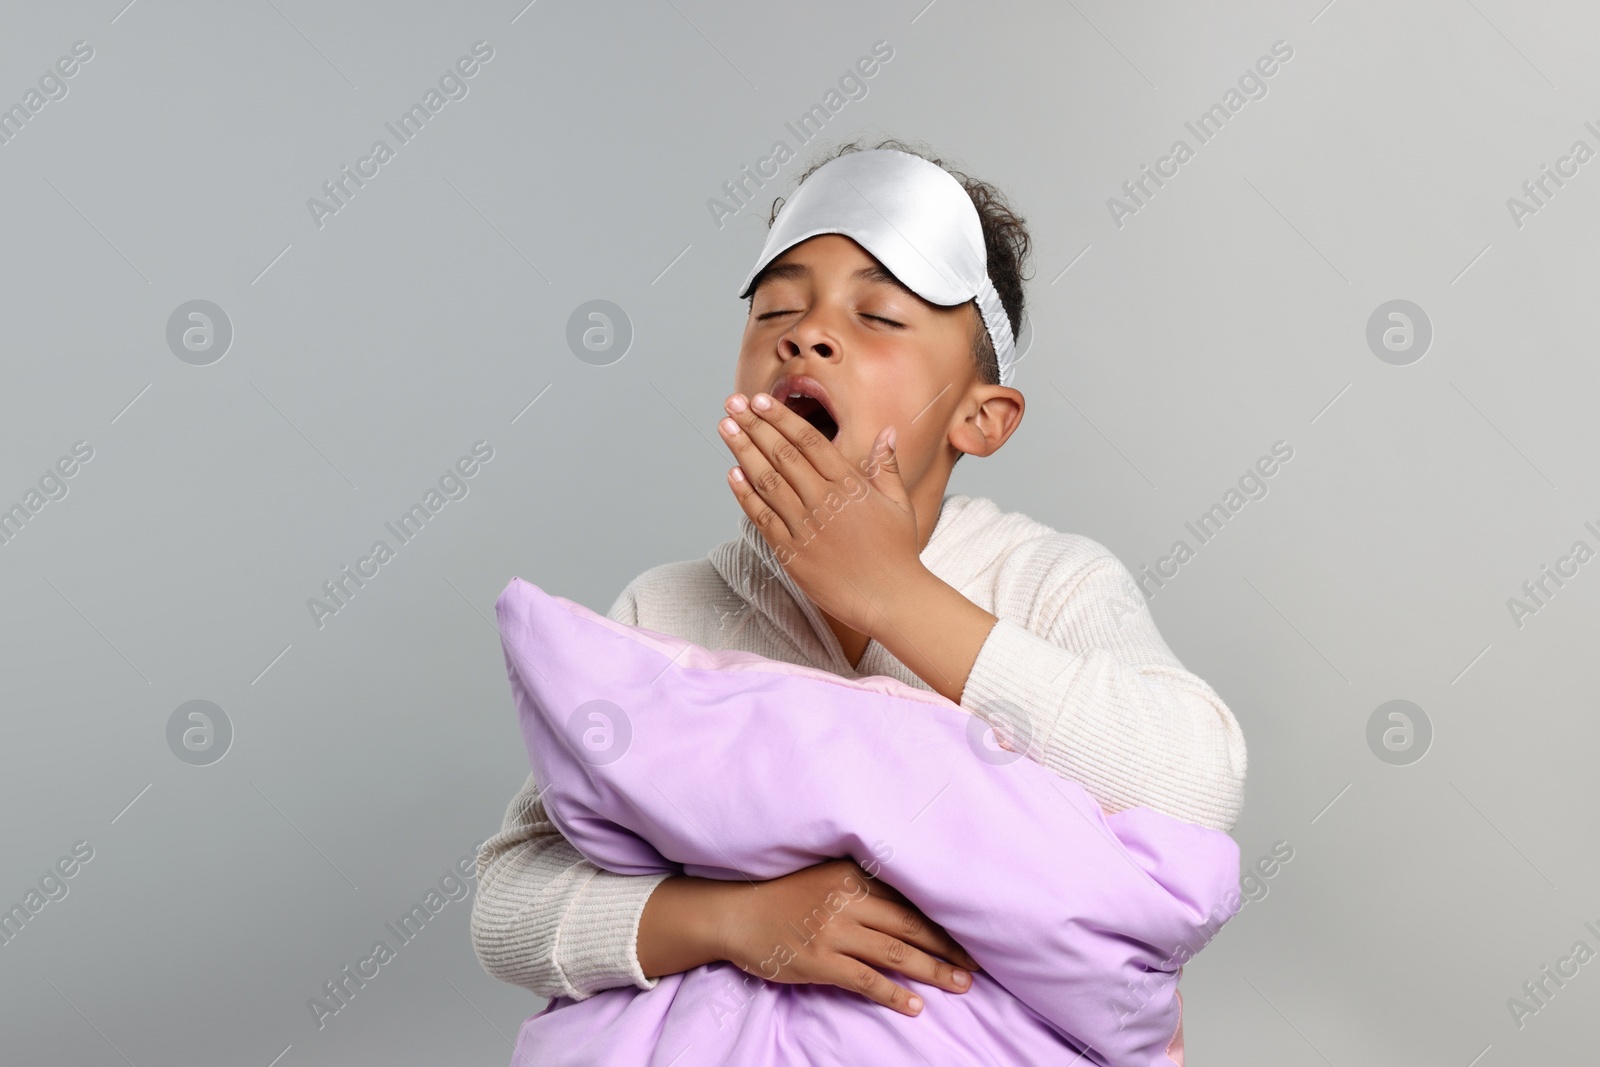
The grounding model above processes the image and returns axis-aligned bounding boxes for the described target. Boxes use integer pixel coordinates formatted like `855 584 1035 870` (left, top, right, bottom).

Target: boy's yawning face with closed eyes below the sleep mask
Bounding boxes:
734 234 1013 488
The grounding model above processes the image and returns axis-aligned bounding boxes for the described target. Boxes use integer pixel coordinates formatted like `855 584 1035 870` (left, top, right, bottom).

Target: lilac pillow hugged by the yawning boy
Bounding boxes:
496 577 1240 1067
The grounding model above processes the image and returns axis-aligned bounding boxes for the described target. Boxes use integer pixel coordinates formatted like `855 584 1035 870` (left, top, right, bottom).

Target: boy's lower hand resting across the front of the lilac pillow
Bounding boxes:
718 859 979 1016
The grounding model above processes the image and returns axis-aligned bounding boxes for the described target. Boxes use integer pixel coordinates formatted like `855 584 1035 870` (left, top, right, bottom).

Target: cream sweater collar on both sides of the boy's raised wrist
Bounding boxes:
707 494 995 678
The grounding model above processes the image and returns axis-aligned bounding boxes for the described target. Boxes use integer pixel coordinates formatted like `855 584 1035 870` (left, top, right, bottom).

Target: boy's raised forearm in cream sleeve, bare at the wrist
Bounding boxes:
870 563 1246 830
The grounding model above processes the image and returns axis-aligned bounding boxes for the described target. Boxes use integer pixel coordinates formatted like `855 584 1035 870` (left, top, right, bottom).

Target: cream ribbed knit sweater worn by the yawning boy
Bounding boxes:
472 494 1245 1000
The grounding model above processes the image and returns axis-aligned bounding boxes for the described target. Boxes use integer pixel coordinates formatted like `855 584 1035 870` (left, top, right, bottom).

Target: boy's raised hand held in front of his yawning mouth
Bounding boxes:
718 394 931 633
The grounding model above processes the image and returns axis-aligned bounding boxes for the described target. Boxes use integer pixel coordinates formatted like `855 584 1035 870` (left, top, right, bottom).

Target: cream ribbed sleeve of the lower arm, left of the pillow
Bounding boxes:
470 584 670 1000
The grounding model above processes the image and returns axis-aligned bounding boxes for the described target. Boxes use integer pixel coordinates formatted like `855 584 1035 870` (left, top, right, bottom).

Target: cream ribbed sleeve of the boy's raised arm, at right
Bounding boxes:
962 539 1246 830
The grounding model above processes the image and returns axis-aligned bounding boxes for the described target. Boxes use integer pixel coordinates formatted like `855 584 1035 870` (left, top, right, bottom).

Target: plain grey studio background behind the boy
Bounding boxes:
0 0 1600 1067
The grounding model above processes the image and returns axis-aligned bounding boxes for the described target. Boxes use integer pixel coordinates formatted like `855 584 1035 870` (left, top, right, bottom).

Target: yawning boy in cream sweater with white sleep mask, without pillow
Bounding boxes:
472 141 1246 1014
